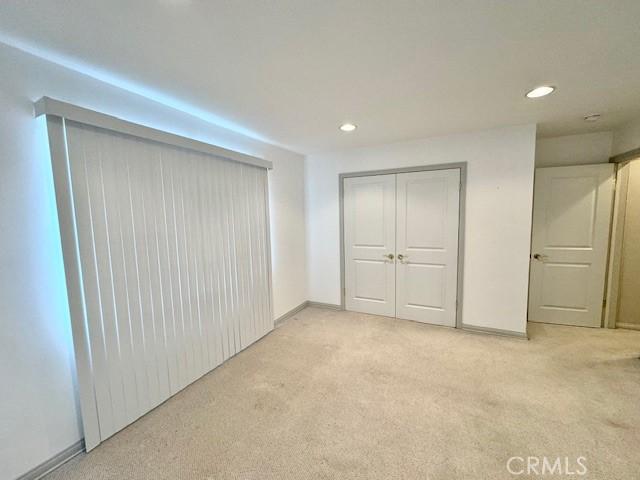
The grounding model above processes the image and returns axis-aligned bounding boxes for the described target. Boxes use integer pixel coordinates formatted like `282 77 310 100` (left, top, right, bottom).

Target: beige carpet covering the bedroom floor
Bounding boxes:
46 308 640 480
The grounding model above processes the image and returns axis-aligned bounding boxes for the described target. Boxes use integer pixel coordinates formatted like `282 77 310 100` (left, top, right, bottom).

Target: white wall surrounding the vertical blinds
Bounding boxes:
0 44 307 480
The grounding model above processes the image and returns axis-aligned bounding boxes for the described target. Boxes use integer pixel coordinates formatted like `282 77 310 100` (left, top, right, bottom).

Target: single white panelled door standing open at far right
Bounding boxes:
529 164 614 327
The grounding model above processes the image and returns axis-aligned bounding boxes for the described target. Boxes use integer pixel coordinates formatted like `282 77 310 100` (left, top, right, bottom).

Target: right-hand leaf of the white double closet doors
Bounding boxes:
396 169 460 327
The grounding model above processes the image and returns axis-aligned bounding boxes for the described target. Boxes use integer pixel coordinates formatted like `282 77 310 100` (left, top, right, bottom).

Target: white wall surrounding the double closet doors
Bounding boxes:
306 125 536 333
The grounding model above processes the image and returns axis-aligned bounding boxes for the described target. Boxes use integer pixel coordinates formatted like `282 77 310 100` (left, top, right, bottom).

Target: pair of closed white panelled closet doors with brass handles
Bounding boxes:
344 168 460 327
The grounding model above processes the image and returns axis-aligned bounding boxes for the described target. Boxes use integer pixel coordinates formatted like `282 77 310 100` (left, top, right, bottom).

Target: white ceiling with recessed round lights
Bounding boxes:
0 0 640 153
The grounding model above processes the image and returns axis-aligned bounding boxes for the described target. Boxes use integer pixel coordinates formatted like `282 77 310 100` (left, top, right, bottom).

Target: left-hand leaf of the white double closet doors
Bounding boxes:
344 175 396 317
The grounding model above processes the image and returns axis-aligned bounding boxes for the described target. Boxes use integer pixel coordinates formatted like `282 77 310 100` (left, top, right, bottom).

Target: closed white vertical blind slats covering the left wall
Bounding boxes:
58 120 273 446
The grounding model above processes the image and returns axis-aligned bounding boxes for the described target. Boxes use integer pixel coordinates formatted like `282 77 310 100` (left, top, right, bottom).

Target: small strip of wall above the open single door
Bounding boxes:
536 132 613 167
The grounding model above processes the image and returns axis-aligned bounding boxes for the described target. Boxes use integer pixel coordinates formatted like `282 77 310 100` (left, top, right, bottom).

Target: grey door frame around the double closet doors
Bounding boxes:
338 162 467 328
